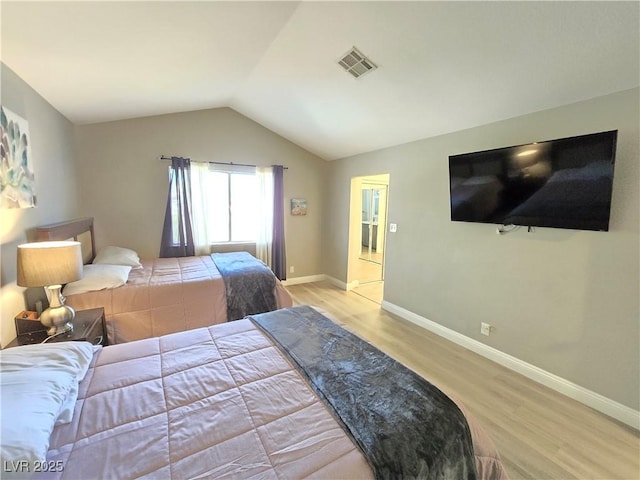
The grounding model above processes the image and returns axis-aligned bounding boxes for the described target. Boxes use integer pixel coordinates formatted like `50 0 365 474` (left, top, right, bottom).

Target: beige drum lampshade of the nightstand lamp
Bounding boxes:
18 241 82 287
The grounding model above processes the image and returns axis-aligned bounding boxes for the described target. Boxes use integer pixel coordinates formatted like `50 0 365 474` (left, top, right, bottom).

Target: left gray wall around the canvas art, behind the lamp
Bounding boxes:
0 64 78 345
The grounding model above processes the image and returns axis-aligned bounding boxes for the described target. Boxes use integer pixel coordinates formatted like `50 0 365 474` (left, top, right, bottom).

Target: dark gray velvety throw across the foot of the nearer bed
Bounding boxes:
250 306 476 480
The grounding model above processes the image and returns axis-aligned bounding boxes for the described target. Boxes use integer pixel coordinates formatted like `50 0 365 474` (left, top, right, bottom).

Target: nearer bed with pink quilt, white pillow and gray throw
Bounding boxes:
2 306 506 480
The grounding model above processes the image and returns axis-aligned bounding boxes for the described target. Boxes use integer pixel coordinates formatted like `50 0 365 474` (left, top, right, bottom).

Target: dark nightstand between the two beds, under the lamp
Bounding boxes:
5 308 107 348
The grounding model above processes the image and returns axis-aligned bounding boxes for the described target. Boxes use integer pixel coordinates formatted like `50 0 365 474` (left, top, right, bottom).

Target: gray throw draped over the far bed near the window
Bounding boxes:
211 252 278 321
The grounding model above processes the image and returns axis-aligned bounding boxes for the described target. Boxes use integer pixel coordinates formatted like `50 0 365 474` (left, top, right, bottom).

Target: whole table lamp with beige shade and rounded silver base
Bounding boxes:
18 241 82 336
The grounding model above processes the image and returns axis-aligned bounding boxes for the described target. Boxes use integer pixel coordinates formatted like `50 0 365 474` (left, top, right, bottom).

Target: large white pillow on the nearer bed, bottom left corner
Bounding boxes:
0 342 96 476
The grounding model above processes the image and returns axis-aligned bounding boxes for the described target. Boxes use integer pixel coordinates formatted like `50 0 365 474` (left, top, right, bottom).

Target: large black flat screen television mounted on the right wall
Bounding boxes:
449 130 618 231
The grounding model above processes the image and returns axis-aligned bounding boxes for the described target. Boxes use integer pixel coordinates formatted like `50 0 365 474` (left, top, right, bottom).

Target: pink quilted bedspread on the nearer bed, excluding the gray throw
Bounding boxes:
41 311 505 479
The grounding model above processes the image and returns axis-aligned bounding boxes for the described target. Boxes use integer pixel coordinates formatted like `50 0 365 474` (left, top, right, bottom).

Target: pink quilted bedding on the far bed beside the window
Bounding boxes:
66 256 292 344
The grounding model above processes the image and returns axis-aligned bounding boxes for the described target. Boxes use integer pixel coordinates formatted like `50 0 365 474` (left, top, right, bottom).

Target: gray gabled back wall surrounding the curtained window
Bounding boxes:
76 108 329 278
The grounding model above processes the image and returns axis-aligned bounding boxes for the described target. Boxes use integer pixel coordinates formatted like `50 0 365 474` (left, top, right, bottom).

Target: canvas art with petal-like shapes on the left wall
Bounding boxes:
0 107 36 208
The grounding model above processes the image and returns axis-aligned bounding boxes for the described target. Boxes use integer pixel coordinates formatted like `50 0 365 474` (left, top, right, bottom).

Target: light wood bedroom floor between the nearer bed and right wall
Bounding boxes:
287 282 640 480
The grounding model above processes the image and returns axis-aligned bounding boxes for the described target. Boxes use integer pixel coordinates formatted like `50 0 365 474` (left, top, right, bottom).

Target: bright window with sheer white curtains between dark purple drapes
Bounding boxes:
172 163 260 244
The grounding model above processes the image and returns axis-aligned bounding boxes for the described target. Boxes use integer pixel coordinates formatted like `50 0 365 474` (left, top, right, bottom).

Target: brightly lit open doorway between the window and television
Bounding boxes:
347 174 389 304
